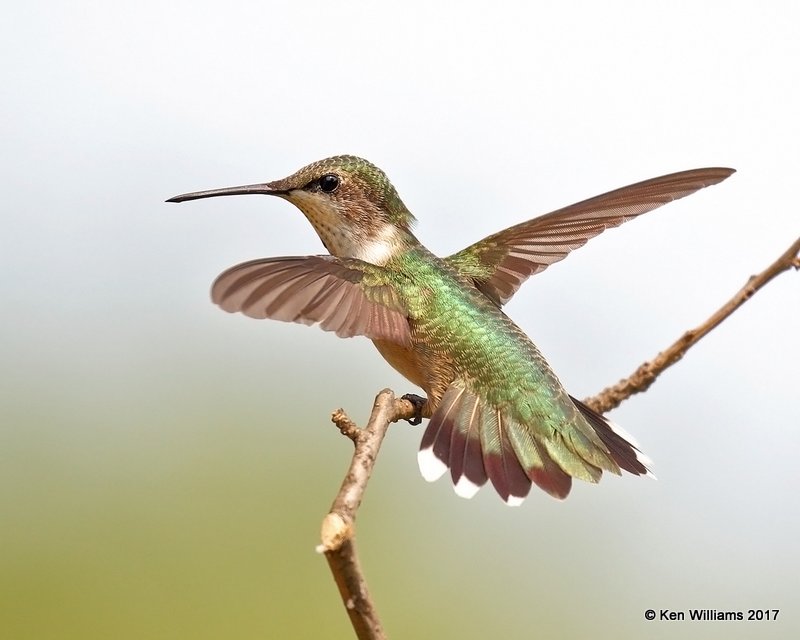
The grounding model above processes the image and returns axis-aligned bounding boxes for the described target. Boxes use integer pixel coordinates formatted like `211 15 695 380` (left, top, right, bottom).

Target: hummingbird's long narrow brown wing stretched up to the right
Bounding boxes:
446 168 734 305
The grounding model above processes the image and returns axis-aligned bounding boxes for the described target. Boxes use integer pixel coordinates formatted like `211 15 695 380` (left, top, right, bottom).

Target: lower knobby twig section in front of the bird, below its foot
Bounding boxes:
317 389 414 640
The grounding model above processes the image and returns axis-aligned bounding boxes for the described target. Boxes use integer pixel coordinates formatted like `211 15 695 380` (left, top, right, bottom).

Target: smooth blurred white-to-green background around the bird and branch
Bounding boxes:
0 0 800 640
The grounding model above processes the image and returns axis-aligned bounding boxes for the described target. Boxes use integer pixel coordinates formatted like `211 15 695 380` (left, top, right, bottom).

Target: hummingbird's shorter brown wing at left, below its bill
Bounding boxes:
211 256 411 346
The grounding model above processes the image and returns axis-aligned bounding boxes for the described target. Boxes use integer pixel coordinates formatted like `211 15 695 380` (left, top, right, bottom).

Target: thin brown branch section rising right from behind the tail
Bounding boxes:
584 238 800 413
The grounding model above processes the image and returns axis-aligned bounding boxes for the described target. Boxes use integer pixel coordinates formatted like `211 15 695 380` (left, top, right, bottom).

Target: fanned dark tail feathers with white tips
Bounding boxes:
417 380 652 506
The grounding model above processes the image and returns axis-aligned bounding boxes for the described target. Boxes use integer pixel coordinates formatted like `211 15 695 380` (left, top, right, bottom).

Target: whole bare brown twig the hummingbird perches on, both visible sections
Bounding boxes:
317 238 800 640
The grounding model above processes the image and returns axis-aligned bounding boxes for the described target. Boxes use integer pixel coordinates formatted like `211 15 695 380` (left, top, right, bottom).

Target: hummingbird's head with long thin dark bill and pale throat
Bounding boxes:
167 156 414 264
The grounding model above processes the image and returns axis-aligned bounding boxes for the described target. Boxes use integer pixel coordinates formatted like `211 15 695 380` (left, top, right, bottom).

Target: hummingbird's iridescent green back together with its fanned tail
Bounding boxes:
378 247 628 502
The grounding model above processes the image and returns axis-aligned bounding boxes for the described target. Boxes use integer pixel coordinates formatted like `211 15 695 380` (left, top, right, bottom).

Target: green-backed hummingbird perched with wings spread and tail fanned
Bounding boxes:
167 155 734 506
